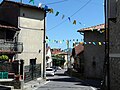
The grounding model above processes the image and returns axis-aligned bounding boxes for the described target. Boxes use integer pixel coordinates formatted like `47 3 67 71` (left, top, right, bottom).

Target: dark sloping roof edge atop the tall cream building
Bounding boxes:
0 0 44 11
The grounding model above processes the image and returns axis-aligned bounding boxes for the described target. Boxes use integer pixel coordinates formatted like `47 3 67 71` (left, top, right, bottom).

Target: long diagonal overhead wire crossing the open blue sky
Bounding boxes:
48 0 92 31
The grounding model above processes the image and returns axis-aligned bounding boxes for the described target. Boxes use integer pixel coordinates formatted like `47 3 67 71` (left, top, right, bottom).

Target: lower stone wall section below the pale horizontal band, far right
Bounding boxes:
109 57 120 90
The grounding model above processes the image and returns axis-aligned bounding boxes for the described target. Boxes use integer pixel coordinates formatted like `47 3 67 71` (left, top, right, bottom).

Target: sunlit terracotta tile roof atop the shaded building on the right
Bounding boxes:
77 24 105 32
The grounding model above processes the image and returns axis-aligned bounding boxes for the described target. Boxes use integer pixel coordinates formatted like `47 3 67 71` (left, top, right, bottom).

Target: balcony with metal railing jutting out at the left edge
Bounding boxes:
0 41 23 53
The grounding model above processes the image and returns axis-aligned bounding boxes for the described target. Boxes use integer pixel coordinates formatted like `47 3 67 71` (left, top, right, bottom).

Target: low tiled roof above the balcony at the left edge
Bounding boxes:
0 21 20 31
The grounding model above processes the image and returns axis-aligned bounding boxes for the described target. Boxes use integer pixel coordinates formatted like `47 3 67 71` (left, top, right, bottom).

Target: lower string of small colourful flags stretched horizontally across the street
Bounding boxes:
46 39 106 45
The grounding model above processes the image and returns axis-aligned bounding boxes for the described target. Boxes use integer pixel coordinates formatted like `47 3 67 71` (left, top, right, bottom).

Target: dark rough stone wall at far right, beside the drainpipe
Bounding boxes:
108 0 120 90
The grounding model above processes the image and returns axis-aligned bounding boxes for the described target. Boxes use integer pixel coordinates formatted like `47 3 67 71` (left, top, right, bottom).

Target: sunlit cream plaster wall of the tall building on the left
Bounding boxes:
18 8 44 65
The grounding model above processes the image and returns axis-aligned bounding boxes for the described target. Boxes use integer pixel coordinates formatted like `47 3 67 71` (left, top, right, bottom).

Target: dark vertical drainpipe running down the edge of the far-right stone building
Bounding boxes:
104 0 110 90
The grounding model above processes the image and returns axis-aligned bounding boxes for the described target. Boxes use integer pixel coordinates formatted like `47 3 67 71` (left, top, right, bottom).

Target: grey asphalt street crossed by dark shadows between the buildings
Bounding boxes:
37 70 99 90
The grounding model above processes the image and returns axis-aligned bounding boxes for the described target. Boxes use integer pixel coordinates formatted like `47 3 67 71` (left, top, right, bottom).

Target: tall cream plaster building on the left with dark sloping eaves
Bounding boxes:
0 0 46 81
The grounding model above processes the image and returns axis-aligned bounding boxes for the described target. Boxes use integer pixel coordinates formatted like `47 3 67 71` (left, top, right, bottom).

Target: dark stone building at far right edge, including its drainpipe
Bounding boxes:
105 0 120 90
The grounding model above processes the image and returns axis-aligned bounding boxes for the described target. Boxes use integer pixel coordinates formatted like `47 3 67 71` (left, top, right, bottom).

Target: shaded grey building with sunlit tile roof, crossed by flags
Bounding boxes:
78 24 105 79
